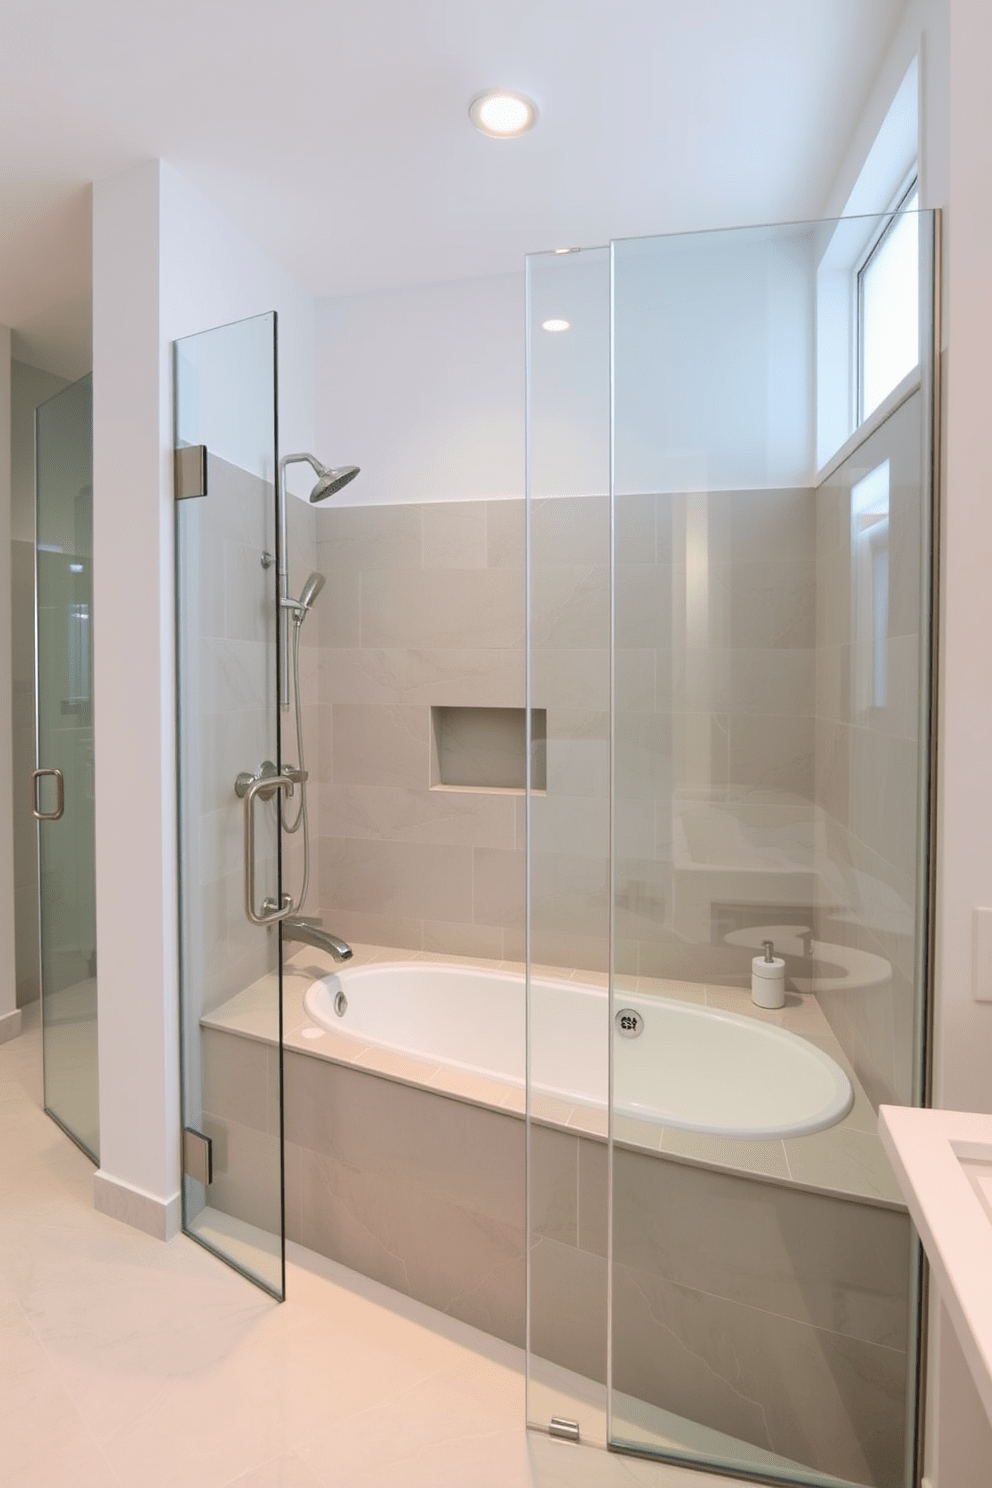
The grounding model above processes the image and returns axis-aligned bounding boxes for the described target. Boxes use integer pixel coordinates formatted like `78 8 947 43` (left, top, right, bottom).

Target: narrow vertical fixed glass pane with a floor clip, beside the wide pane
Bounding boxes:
526 248 610 1442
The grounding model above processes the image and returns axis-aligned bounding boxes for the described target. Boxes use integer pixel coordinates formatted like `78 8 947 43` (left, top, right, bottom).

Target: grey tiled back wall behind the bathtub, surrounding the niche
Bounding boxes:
317 490 815 985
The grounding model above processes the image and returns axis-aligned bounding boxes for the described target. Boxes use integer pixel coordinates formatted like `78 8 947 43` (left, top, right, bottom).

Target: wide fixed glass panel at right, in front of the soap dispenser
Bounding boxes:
608 214 933 1488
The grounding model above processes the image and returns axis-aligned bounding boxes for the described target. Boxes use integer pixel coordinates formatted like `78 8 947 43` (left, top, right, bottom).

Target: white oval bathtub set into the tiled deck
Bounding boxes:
303 961 854 1137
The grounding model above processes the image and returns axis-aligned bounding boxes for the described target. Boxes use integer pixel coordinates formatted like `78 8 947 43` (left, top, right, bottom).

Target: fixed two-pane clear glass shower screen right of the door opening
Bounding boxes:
526 211 935 1488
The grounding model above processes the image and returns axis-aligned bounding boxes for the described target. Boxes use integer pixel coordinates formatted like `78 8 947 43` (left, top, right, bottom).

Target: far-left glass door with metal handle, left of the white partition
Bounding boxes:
34 376 100 1162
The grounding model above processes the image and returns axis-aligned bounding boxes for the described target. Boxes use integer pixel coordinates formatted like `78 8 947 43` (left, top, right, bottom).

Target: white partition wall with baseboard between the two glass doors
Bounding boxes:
94 161 314 1237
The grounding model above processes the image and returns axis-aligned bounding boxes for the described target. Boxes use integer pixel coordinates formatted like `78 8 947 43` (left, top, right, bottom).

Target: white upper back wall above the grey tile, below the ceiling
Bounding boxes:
317 234 812 506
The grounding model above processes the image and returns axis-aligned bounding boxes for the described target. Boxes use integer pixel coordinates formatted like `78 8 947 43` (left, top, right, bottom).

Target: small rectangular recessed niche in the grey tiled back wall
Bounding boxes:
431 708 547 793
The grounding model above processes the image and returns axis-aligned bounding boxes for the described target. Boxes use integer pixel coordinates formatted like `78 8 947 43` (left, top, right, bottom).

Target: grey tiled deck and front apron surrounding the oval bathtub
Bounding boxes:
204 946 910 1488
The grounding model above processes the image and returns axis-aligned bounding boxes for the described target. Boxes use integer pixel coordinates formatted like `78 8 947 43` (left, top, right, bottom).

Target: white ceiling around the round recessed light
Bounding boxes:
0 0 904 375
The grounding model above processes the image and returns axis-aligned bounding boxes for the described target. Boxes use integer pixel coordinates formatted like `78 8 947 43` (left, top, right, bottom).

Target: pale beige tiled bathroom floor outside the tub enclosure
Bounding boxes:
0 1005 737 1488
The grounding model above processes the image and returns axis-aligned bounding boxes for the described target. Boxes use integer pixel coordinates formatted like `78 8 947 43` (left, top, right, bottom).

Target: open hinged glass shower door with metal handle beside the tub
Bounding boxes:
175 315 284 1298
